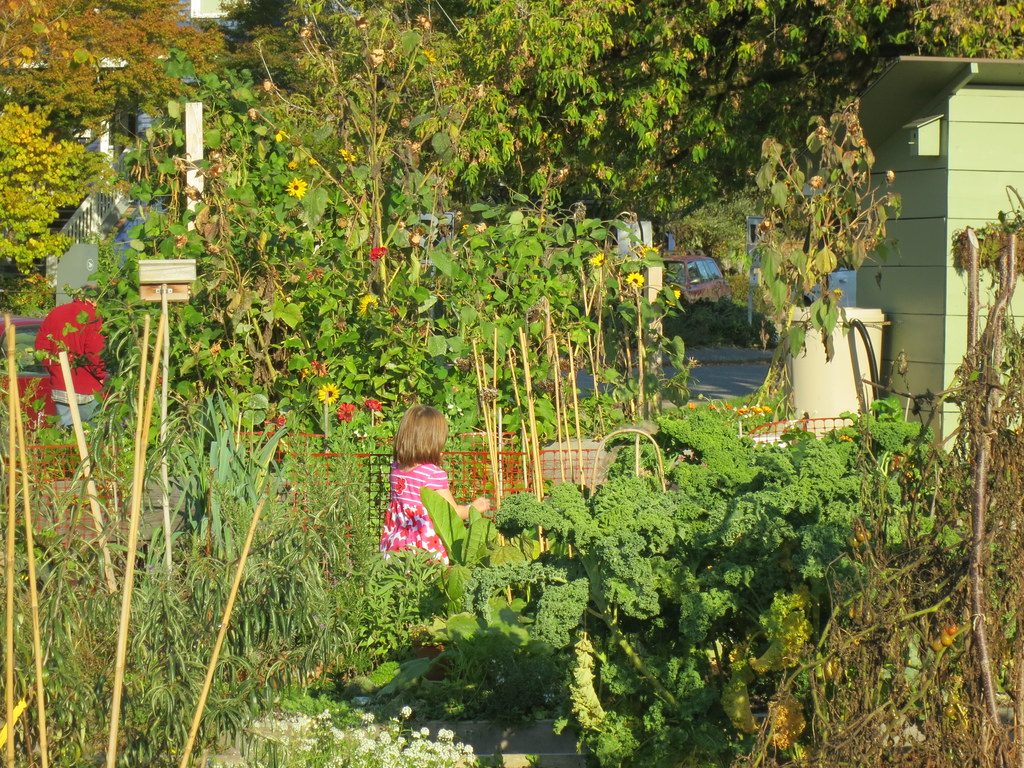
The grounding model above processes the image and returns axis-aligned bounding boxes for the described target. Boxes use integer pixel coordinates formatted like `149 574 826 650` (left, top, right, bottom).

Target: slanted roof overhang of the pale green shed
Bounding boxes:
860 56 1024 145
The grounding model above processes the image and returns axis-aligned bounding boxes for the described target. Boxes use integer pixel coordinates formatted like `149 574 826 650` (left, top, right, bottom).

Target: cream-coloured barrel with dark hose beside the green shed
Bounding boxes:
783 307 885 419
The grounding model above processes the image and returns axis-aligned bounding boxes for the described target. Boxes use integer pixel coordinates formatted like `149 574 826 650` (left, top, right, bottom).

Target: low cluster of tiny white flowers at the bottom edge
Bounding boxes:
241 707 478 768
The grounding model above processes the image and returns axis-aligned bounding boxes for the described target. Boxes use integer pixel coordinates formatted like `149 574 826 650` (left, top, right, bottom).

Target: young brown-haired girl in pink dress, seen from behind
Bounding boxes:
381 406 490 563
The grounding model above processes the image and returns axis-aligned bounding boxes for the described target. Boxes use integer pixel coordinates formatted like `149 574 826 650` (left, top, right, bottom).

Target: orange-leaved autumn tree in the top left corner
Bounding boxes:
0 0 221 136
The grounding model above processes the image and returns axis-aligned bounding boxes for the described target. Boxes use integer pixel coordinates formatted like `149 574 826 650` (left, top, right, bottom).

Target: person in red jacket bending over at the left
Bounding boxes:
36 299 106 427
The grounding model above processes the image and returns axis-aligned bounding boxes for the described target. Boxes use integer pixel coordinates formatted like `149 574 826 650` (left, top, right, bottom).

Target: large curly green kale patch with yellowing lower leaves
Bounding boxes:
467 407 916 765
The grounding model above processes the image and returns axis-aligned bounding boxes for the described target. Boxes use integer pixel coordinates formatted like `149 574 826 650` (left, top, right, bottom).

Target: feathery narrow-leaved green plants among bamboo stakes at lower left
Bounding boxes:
4 403 385 766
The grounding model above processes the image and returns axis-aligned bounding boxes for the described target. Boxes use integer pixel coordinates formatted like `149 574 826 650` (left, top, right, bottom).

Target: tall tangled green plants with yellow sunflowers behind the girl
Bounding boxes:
112 54 675 437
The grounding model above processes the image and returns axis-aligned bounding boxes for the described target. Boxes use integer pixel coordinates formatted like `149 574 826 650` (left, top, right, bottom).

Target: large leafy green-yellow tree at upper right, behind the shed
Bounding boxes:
456 0 1024 214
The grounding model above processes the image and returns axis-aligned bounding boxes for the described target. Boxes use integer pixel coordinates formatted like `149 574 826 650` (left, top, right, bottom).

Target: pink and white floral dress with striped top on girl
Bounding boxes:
381 464 449 563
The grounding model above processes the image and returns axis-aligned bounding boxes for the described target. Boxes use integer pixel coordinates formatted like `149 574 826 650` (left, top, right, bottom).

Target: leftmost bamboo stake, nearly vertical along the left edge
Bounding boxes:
3 314 18 768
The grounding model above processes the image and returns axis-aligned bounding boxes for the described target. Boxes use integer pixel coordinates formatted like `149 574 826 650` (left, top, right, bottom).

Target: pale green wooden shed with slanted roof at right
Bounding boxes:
857 56 1024 433
